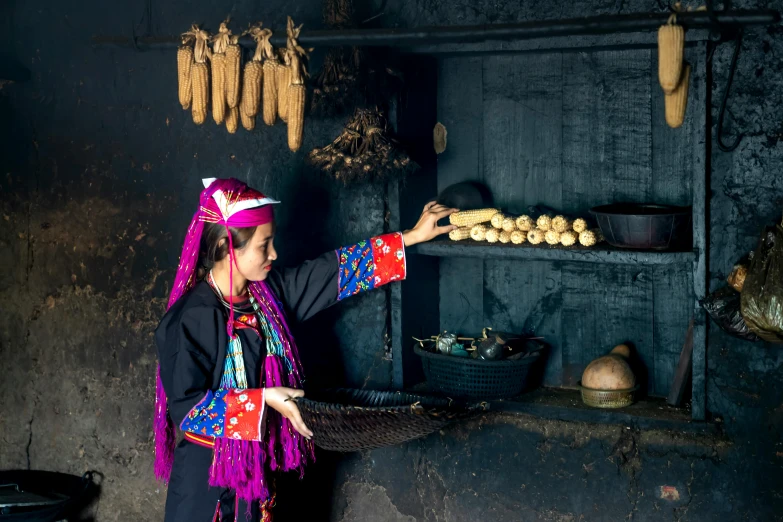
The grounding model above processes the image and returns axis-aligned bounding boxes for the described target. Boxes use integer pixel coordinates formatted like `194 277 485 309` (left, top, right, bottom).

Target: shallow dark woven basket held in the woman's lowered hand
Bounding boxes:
296 388 486 452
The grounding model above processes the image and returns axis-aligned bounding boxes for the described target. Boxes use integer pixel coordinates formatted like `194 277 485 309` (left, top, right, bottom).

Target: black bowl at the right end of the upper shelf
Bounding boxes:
590 203 692 250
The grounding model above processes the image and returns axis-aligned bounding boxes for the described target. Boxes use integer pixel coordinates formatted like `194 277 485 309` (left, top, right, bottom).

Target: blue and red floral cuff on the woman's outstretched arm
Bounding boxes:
337 232 406 301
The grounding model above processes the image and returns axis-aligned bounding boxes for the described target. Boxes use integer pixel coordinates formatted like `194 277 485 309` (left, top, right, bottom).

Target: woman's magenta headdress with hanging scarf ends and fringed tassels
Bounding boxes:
154 178 313 500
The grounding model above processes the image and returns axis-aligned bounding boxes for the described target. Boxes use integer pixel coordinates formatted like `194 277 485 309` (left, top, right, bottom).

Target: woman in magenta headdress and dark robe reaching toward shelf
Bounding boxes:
155 179 456 522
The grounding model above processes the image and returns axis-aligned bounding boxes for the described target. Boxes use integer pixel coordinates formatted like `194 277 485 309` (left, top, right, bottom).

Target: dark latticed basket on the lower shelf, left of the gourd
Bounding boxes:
413 346 539 400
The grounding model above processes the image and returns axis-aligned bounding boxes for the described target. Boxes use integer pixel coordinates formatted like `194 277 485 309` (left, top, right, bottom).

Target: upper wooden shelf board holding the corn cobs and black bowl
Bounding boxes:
408 241 696 265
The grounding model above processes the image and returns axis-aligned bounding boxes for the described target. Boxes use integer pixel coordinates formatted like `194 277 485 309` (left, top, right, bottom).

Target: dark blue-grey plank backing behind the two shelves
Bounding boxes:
438 49 704 396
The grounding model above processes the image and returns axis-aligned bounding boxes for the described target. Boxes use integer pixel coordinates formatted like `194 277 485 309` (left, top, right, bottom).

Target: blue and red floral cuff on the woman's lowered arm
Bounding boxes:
180 388 265 441
